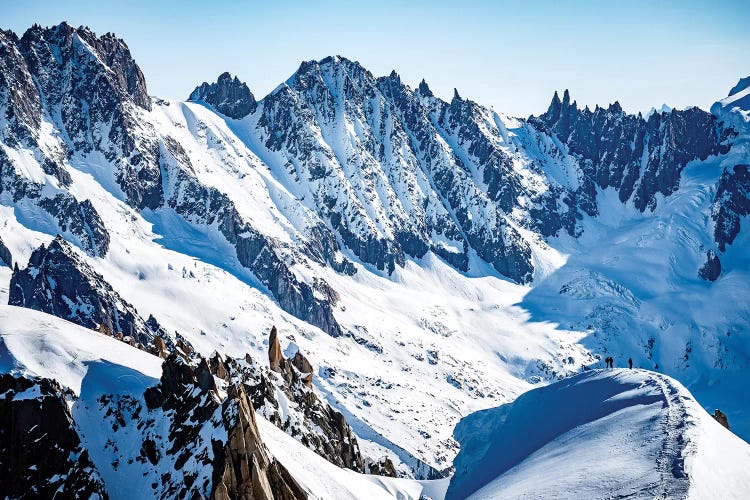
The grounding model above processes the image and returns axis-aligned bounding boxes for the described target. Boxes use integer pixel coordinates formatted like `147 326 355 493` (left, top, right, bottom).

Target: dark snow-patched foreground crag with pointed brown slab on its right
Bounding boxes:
125 353 306 500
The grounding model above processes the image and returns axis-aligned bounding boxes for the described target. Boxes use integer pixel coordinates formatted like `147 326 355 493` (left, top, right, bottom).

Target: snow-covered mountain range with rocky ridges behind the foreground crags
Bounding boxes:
0 23 750 497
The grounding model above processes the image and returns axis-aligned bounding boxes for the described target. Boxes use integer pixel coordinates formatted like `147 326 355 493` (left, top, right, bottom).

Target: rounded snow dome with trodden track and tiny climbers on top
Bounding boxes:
447 369 750 499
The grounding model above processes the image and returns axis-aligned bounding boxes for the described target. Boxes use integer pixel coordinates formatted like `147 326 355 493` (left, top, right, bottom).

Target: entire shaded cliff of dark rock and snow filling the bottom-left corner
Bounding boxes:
0 354 306 500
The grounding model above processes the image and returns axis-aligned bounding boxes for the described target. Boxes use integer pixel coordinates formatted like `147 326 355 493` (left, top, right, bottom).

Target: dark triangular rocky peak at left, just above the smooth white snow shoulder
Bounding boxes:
8 235 174 355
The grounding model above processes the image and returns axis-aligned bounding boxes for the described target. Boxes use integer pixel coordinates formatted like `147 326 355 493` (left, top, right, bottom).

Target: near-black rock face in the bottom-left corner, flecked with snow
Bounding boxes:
0 374 107 498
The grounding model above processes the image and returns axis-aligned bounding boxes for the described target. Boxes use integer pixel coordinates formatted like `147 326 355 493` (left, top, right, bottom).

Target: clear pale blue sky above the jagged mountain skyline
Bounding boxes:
0 0 750 116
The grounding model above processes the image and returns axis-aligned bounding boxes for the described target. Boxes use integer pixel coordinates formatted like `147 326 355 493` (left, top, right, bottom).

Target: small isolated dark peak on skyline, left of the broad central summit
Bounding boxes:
188 73 258 119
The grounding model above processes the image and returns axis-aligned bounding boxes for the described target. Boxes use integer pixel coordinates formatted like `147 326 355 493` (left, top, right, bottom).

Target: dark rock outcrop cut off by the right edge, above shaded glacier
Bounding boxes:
711 165 750 252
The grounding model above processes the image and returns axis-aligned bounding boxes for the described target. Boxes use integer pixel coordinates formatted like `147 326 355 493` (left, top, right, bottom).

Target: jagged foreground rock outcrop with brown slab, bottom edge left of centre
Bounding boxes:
144 354 306 500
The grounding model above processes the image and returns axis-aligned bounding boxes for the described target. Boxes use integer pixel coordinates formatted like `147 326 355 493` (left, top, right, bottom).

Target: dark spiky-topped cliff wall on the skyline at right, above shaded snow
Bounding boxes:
529 90 722 211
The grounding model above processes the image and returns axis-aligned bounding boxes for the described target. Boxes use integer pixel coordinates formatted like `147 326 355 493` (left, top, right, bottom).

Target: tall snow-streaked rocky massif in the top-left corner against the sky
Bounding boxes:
0 23 162 208
